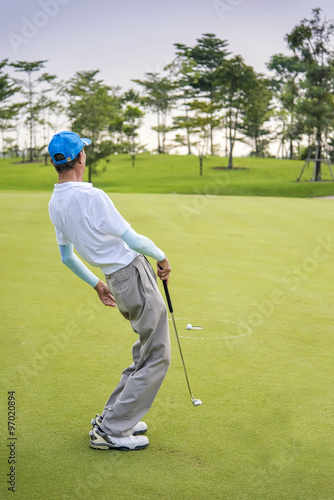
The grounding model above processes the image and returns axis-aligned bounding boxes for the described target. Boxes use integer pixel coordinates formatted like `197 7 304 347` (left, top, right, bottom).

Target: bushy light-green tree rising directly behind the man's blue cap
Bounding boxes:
67 70 115 182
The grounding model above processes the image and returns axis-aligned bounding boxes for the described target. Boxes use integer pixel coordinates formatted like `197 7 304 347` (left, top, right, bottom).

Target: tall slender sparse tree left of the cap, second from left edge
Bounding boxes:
11 60 56 162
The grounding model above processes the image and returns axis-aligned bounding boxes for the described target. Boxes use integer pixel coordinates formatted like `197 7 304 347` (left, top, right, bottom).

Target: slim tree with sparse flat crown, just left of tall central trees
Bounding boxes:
132 73 175 154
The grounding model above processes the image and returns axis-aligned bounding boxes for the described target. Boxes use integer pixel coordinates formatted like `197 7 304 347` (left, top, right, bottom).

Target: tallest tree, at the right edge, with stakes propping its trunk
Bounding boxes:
286 8 334 181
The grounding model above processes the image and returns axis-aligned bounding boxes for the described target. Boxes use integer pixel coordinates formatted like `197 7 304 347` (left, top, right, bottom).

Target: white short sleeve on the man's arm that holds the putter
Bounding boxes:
91 189 130 238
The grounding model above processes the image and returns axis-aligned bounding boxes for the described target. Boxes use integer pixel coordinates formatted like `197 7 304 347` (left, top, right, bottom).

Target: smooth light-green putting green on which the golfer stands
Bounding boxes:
0 191 334 500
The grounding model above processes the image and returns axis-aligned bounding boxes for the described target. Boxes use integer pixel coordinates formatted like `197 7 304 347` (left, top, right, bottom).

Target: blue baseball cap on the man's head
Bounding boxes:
48 131 92 165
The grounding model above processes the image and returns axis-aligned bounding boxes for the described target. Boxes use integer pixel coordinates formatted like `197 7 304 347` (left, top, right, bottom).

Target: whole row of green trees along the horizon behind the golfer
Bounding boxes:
0 8 334 180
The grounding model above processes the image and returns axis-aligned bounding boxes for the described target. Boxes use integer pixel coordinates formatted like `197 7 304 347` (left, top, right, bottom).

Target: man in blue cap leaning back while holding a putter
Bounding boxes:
49 132 171 450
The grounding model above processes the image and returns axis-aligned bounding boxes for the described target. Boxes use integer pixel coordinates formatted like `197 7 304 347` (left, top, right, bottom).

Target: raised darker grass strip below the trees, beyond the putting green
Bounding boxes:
0 154 334 198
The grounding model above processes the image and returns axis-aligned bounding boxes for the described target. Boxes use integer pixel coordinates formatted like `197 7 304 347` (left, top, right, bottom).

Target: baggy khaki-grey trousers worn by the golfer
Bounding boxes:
101 255 171 437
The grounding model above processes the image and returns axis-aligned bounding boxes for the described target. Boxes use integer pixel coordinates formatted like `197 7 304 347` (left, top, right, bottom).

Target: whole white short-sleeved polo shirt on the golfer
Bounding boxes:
49 182 139 274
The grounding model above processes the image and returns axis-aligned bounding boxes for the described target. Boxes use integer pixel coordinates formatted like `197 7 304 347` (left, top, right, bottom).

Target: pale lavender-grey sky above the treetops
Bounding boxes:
0 0 334 151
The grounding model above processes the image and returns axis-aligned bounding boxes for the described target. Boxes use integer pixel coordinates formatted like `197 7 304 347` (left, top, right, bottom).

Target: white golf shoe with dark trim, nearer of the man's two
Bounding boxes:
89 426 149 451
